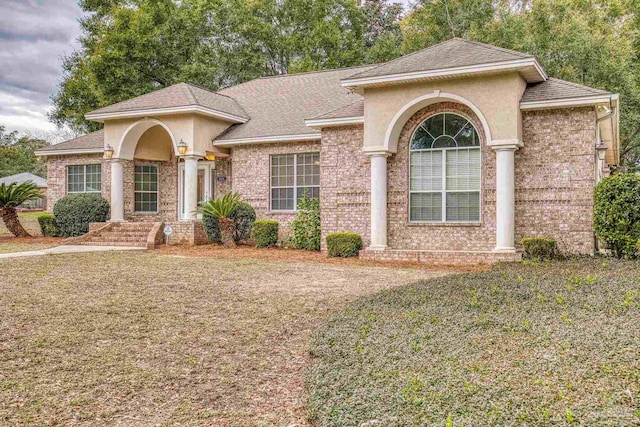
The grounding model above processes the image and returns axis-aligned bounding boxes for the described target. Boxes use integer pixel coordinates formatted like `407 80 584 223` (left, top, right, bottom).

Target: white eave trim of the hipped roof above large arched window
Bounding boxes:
340 57 548 89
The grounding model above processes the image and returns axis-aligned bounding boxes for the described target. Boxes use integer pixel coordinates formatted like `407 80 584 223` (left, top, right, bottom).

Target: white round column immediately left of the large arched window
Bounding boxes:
369 152 389 250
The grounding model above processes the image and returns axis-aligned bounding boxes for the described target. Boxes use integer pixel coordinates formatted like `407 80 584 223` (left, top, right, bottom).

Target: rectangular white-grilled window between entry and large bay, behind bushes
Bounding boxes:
271 153 320 211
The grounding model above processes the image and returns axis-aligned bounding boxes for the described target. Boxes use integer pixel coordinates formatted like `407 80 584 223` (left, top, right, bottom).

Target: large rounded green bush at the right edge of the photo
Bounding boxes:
593 173 640 258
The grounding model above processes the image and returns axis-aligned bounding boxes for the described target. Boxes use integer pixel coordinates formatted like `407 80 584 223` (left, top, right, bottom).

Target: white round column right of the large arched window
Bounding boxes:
493 144 519 253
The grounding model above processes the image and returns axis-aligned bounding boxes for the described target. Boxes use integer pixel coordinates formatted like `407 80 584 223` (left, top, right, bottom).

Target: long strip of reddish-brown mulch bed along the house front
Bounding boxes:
156 245 490 272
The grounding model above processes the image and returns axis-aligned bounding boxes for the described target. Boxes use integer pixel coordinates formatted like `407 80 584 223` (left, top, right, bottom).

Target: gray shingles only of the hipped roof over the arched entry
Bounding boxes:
89 83 249 119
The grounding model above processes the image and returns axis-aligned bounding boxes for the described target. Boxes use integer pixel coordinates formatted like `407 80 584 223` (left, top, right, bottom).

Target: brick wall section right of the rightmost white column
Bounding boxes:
516 108 596 254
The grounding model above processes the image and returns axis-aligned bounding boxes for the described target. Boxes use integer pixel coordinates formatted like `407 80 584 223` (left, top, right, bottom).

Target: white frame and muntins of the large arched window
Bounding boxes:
407 111 482 224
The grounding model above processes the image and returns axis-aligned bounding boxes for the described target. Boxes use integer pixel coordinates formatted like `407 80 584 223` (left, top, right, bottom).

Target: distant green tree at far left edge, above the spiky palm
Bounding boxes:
0 125 49 178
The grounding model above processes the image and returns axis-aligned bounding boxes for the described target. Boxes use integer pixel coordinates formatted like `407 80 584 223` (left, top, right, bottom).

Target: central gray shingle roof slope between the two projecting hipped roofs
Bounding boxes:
216 66 372 142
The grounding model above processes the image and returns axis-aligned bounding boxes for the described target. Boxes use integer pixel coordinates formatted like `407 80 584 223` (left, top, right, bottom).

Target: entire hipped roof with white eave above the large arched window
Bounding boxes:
342 38 547 87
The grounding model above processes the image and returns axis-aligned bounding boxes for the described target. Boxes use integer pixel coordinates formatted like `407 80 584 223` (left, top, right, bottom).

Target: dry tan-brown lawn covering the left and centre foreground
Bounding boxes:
0 252 445 426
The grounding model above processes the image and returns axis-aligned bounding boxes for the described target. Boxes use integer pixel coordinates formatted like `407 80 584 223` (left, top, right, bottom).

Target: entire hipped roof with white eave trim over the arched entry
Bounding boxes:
86 83 249 123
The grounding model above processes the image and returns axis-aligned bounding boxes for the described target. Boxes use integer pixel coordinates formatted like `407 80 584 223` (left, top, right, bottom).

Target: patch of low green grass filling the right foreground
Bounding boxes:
307 259 640 427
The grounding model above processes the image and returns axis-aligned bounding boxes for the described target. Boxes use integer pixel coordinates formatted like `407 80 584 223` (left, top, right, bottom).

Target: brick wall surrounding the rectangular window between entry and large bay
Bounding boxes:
229 141 322 237
